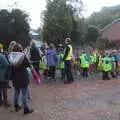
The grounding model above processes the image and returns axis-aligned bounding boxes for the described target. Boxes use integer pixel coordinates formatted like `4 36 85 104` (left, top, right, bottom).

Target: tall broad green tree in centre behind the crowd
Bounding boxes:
42 0 82 44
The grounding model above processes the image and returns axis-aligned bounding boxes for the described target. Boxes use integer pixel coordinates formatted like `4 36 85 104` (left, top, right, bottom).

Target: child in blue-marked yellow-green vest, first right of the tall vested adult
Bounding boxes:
80 51 90 77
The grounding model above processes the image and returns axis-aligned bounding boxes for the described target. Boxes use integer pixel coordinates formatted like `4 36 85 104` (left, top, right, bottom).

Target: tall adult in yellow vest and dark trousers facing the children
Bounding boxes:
63 38 74 84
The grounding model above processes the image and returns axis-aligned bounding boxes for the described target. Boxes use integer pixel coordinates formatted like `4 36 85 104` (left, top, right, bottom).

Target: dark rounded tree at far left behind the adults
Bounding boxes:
0 9 30 48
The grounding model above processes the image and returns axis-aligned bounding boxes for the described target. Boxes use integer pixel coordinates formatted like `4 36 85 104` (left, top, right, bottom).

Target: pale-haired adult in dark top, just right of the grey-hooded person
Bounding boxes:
30 40 40 75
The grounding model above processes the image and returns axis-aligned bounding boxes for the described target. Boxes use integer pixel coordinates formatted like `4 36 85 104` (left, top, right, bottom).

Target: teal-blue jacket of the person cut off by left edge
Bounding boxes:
0 53 9 82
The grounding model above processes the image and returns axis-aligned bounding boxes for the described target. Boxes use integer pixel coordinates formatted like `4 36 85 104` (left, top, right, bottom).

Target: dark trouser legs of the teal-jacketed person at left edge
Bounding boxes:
0 88 8 104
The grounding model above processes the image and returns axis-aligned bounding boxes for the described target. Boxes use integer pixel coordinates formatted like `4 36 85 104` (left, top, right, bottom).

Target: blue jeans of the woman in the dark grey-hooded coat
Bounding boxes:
14 88 28 108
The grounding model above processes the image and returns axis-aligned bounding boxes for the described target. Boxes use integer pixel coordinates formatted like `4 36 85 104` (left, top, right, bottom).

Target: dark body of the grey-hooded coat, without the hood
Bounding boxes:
12 57 30 88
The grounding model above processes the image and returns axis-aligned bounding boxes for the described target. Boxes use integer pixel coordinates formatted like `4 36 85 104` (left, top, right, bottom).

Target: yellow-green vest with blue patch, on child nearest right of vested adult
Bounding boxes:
80 53 90 68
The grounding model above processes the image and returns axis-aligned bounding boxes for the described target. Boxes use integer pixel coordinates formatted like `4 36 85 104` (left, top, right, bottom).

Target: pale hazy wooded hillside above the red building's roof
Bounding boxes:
86 5 120 29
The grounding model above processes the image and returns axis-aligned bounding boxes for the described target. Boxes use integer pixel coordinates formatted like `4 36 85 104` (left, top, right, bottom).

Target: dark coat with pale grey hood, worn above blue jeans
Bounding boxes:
8 53 30 88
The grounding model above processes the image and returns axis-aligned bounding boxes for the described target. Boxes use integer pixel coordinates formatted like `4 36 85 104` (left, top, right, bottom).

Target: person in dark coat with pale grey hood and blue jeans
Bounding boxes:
8 44 33 114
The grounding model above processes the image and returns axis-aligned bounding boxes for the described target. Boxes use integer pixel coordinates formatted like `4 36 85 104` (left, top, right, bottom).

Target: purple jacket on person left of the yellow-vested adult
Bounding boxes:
47 49 58 67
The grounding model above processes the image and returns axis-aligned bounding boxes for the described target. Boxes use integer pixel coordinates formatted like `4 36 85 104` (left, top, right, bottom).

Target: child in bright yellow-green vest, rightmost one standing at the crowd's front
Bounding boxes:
102 53 112 80
